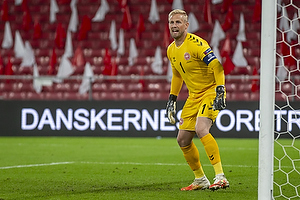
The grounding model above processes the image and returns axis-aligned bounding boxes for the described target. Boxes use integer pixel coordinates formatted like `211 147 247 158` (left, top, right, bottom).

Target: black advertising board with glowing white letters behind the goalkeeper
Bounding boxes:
0 101 300 138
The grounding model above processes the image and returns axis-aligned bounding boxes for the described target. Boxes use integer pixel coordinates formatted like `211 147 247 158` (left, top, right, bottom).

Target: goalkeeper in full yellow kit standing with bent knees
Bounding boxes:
166 9 229 190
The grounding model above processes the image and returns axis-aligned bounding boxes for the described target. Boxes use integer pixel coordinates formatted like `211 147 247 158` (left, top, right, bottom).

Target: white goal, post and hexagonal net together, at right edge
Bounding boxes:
258 0 300 200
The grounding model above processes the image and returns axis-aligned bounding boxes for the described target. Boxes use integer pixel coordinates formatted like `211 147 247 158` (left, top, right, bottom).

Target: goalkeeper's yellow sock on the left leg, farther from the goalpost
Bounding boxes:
180 141 204 178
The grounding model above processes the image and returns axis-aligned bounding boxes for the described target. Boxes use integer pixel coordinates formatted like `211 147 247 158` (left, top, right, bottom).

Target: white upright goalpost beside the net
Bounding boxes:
258 0 277 200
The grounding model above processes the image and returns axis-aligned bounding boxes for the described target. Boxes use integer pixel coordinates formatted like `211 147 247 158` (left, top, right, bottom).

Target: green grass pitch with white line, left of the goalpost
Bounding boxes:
0 137 258 200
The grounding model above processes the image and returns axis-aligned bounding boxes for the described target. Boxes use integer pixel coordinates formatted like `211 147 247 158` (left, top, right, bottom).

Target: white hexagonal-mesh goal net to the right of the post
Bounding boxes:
273 0 300 199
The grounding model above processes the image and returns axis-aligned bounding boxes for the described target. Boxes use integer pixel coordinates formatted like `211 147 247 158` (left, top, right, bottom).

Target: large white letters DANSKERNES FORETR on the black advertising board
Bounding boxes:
21 108 300 132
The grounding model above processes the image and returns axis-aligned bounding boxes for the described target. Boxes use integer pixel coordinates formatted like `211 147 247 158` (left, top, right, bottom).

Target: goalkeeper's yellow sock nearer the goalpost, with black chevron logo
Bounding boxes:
200 133 223 174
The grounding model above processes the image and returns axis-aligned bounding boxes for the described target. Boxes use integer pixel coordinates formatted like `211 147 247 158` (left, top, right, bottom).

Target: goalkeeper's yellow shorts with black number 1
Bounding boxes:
179 93 219 131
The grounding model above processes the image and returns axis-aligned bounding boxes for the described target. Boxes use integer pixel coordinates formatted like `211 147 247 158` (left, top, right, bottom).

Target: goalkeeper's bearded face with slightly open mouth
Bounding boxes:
169 14 188 40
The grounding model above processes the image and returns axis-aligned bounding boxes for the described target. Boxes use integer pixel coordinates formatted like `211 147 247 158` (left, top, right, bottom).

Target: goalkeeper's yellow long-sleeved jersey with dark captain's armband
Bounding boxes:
167 33 225 96
